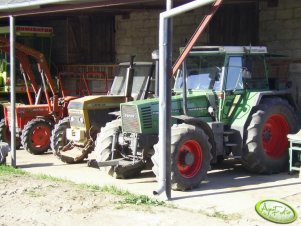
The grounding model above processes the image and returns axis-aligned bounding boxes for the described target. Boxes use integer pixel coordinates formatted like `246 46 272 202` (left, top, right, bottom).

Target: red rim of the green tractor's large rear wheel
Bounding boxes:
262 114 289 159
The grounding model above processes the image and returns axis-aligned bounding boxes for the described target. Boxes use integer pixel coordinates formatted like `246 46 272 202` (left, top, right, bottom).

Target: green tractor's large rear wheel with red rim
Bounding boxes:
242 97 298 174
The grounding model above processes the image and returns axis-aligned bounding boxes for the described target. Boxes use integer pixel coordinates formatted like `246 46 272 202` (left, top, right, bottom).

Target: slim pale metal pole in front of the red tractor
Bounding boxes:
9 16 16 168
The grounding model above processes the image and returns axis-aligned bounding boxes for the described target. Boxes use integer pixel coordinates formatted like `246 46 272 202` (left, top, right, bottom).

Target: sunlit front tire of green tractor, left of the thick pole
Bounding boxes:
94 119 146 179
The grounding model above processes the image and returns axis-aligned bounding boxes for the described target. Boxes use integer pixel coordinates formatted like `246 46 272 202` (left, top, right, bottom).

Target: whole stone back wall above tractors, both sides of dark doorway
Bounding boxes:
116 0 301 62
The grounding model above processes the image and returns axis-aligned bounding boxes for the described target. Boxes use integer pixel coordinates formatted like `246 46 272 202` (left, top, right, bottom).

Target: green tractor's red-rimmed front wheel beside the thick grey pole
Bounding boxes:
152 123 212 191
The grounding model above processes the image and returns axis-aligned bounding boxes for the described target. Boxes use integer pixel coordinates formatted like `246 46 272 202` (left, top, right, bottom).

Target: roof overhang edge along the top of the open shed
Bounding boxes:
0 0 258 18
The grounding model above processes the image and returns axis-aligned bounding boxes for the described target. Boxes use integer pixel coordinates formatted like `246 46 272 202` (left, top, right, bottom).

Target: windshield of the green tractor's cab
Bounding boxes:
174 53 225 91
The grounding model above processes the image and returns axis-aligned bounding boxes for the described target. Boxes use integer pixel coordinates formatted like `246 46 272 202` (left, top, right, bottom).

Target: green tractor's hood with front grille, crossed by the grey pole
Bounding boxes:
120 91 215 134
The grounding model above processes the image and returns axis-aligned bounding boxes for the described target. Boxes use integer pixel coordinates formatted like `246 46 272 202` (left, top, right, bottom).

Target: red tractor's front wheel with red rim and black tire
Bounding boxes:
21 118 53 155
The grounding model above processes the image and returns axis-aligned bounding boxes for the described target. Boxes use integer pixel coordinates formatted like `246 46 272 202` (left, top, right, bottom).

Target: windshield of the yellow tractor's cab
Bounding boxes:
109 64 151 99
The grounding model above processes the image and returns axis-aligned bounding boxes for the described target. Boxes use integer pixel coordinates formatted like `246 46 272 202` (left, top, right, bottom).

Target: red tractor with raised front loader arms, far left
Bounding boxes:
0 37 77 154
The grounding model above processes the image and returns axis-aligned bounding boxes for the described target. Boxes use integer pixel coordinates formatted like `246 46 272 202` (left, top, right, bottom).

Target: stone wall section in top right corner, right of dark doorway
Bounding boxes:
259 0 301 58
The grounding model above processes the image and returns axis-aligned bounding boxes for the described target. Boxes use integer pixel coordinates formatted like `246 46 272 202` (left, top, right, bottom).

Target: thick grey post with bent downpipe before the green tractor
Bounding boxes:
153 0 215 196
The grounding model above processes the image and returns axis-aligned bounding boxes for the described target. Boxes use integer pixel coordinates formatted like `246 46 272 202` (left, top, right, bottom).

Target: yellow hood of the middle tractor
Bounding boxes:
68 95 127 112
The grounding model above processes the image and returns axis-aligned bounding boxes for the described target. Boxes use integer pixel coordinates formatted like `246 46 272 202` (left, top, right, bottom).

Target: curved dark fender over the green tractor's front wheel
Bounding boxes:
171 115 217 163
